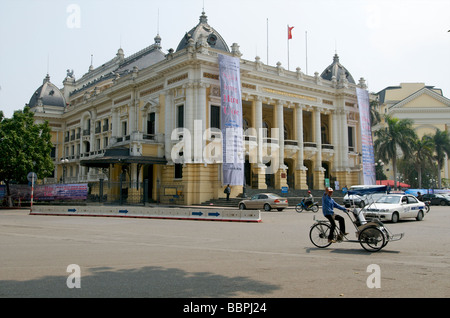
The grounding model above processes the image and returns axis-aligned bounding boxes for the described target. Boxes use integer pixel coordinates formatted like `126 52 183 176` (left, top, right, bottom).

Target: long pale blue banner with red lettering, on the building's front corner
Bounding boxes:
219 54 245 185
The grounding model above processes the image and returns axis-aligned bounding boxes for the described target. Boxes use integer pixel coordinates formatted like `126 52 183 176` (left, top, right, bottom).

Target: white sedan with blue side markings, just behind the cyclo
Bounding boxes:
363 194 425 223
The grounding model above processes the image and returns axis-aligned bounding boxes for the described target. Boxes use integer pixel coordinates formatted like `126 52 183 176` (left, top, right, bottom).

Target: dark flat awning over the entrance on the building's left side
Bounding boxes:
80 148 167 168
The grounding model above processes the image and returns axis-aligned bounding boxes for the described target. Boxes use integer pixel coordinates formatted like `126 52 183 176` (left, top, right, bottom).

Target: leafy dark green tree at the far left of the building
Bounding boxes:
0 107 54 206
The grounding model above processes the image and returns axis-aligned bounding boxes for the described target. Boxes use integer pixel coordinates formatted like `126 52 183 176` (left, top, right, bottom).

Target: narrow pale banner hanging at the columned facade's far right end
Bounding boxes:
356 87 376 185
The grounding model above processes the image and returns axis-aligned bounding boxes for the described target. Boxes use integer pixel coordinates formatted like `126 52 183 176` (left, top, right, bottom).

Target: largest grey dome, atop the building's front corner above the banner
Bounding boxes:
177 12 230 52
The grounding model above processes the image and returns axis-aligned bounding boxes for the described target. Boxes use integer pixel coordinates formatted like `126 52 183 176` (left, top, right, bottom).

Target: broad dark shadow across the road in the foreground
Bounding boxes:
0 266 280 298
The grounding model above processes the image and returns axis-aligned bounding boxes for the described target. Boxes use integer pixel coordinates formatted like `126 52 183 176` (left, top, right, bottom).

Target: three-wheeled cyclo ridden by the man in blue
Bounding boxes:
309 186 404 252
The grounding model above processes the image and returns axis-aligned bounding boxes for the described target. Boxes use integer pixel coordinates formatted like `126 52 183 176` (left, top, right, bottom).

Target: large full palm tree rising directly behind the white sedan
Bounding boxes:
374 115 417 189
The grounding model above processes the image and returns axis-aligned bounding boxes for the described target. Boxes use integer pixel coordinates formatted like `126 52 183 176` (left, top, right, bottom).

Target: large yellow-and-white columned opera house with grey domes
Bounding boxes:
29 13 372 204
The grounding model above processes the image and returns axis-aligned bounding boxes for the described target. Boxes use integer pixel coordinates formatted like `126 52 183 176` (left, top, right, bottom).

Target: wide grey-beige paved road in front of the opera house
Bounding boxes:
0 207 450 298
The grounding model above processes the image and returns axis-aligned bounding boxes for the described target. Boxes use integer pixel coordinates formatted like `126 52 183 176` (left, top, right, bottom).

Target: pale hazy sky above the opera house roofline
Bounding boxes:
0 0 450 117
